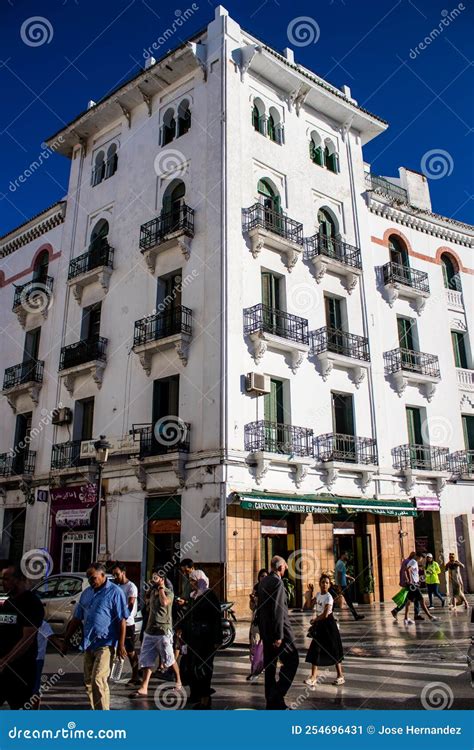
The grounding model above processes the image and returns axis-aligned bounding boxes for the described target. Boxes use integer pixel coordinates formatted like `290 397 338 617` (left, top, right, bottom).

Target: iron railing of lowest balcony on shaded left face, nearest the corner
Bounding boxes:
130 424 191 458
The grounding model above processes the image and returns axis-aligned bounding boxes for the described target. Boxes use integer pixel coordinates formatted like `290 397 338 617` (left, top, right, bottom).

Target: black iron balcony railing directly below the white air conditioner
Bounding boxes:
244 419 313 456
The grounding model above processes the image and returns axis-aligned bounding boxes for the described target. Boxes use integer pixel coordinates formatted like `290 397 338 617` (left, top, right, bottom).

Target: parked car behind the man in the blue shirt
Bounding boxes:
32 573 142 648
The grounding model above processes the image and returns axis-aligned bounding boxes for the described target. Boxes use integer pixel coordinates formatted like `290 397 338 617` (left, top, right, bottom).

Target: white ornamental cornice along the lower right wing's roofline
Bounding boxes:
367 191 474 247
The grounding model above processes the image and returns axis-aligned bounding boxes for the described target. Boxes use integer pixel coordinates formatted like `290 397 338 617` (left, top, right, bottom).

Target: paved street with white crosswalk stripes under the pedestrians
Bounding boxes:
7 605 474 710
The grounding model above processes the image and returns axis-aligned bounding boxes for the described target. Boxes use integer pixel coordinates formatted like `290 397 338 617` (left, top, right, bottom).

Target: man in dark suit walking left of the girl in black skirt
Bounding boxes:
257 556 298 710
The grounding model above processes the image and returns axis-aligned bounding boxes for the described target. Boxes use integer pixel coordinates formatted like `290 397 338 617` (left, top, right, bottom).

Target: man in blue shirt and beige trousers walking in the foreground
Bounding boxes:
63 563 130 711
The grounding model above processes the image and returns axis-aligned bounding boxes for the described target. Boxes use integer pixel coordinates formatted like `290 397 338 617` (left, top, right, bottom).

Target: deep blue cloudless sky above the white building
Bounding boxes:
0 0 474 234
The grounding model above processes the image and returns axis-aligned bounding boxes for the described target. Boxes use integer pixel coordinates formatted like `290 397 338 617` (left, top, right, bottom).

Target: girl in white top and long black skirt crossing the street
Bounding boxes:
305 574 345 688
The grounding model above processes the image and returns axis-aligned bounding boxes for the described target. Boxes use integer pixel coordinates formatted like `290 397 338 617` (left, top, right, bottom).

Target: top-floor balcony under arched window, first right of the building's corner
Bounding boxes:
242 203 303 271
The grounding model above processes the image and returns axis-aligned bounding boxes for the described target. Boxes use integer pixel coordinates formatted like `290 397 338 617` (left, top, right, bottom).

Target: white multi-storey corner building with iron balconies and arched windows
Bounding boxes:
0 7 474 612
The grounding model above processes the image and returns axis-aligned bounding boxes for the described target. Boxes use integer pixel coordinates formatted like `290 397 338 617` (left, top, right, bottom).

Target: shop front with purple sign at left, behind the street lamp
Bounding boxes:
50 483 97 573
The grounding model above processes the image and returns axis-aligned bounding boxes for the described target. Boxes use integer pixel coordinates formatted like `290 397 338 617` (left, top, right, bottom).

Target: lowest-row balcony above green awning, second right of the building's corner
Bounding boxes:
314 432 378 492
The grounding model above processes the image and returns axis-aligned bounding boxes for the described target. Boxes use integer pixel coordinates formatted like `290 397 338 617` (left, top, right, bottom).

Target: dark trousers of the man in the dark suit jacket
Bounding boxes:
263 640 299 709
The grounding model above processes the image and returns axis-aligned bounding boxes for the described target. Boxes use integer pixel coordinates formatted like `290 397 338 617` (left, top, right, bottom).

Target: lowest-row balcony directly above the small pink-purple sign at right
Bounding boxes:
392 444 449 493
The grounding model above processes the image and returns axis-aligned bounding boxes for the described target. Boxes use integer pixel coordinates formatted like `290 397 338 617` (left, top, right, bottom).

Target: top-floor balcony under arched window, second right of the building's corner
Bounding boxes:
304 234 362 294
